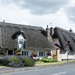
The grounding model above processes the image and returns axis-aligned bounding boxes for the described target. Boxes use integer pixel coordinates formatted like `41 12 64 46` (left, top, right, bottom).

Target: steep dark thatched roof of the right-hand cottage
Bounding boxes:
53 27 75 51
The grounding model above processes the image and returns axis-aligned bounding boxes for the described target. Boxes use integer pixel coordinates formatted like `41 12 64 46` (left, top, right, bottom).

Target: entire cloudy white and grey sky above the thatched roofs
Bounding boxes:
0 0 75 32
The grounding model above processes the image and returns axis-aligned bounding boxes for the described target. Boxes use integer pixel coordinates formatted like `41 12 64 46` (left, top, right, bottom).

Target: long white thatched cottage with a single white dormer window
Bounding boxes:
0 22 55 58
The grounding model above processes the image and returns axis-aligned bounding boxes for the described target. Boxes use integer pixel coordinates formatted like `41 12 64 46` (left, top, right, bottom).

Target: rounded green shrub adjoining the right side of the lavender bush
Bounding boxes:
22 56 35 66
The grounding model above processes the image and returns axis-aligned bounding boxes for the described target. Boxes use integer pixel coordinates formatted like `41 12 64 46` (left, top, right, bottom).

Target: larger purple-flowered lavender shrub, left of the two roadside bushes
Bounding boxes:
2 56 24 67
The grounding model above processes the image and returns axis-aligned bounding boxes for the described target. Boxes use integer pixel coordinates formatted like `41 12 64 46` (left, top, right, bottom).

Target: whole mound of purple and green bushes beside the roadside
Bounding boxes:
2 55 35 67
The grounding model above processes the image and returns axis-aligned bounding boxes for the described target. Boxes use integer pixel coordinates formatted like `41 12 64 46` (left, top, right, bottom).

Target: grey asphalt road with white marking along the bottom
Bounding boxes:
0 64 75 75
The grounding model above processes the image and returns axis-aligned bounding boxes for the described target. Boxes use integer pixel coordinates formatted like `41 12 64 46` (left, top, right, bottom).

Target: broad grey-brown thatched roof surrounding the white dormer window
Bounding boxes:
0 22 55 50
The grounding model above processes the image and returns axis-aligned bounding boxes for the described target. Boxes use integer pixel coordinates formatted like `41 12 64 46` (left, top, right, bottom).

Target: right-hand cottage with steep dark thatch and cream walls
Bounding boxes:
50 27 75 61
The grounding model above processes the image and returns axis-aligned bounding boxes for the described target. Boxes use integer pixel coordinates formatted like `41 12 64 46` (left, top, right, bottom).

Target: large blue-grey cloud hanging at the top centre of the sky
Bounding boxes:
2 0 70 15
